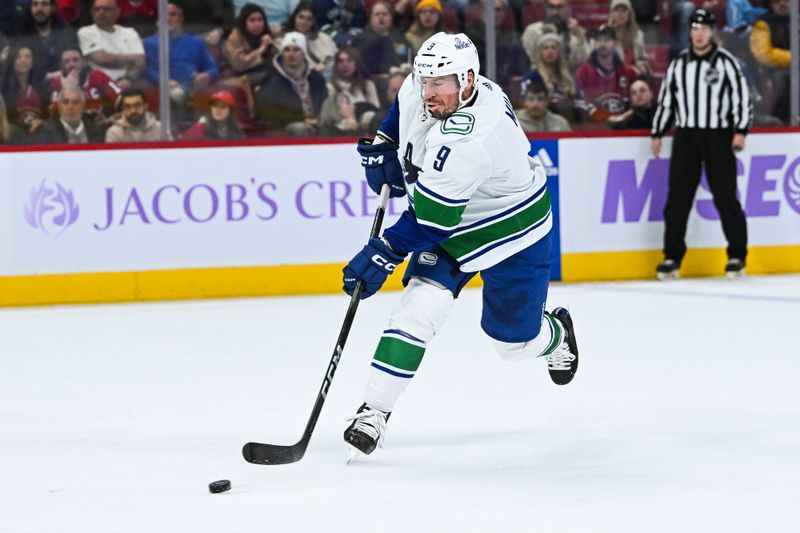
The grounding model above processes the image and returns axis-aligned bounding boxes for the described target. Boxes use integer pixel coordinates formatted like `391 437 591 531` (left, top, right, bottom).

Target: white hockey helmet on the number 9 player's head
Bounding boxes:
414 31 481 103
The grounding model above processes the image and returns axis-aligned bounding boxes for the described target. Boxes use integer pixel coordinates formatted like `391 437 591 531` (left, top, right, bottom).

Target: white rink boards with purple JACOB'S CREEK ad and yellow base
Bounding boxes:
0 132 800 306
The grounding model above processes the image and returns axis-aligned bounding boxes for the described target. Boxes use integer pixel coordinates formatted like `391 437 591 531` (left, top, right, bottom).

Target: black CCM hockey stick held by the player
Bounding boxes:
242 185 389 465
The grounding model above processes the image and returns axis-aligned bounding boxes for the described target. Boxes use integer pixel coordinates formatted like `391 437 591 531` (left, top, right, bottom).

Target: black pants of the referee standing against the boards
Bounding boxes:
664 128 747 262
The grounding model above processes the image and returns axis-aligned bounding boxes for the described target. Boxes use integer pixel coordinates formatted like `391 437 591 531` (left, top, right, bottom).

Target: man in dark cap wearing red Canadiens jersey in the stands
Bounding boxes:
575 25 636 121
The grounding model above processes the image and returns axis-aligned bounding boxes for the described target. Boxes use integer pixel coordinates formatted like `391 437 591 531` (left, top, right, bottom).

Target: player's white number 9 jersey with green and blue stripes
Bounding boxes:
382 71 552 272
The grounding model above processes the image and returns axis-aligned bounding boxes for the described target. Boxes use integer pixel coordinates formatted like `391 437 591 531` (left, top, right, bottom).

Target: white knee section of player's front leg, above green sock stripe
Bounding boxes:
387 277 453 343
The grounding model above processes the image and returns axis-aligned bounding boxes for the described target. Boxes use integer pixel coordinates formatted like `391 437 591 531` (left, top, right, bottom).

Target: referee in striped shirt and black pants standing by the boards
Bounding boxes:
651 9 752 280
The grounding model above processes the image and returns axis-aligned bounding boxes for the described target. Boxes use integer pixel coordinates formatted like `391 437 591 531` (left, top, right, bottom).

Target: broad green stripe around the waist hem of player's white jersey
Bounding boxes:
442 190 550 259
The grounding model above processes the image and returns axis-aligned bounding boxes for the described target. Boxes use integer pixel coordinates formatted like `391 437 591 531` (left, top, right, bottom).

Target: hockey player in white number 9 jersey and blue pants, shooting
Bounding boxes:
344 33 578 454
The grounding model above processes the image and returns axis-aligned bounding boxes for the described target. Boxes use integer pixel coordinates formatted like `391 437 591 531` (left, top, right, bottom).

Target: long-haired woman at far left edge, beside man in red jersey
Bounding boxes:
0 45 47 135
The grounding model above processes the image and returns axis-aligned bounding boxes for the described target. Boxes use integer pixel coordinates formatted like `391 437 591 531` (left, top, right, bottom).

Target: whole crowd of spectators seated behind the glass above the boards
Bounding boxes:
0 0 797 145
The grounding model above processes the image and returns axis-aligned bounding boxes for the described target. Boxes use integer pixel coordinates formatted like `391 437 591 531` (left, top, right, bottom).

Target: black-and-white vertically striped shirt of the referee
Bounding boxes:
650 46 753 137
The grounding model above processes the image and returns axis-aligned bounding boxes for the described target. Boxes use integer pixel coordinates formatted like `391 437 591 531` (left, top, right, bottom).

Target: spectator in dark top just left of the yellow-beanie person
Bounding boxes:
353 0 412 76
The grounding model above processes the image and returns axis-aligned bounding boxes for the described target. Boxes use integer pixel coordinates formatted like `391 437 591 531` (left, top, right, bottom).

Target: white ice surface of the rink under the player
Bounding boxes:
0 276 800 533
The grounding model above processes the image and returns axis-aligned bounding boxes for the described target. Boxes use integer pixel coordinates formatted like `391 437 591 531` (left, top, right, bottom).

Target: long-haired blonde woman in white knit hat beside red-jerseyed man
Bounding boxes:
522 24 587 124
